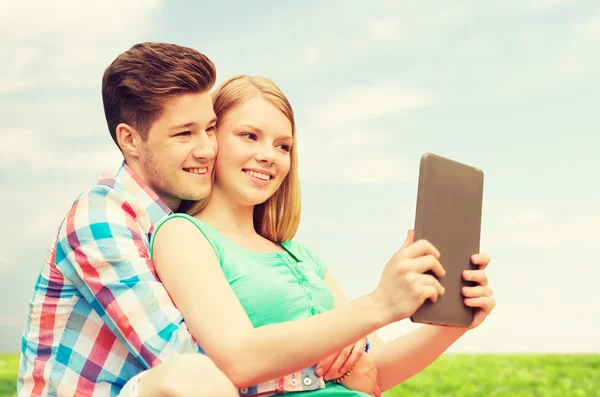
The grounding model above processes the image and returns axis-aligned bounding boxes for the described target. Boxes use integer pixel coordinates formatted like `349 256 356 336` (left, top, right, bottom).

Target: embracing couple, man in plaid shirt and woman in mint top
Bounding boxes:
17 43 495 397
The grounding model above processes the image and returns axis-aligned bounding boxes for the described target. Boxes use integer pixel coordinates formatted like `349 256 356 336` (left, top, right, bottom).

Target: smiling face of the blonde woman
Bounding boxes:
214 98 293 205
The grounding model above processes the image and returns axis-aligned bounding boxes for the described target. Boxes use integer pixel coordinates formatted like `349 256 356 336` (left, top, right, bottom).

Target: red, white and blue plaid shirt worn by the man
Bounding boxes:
17 164 324 397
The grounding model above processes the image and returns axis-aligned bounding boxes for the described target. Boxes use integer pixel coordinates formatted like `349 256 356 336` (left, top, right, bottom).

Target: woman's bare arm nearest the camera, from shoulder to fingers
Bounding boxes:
153 218 443 387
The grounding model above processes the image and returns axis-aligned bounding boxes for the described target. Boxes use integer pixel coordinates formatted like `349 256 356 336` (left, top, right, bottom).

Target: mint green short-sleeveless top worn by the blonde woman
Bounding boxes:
150 214 368 397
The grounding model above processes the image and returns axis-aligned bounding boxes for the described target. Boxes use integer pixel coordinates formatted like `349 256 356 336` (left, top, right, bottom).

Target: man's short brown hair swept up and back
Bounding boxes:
102 42 217 146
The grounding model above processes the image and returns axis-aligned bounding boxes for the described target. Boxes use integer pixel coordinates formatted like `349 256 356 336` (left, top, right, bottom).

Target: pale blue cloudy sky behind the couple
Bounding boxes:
0 0 600 352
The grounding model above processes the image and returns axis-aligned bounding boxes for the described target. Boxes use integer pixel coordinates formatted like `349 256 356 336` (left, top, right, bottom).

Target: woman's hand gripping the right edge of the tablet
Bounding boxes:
462 254 496 329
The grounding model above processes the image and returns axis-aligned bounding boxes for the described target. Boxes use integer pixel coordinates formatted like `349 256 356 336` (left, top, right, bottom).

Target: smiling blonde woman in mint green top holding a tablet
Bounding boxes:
151 76 495 396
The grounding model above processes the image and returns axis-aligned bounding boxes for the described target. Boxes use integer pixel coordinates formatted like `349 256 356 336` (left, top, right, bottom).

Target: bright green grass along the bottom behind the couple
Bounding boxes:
0 354 600 397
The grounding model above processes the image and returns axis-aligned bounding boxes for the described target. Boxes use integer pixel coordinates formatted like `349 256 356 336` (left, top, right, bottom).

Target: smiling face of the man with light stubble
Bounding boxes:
139 92 217 209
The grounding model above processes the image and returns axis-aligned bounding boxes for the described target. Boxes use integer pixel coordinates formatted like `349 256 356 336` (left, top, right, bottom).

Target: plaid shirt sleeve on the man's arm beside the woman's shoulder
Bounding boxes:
56 187 202 368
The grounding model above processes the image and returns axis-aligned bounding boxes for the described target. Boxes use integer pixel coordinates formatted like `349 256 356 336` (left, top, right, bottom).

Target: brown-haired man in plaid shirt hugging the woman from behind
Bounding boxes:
17 43 237 396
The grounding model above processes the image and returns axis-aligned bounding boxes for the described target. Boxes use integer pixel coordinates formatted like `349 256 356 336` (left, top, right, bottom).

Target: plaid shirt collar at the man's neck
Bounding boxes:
115 161 173 225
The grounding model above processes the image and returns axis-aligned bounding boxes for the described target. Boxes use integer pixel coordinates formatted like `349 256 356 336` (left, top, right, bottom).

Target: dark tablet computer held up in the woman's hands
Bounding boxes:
410 153 483 327
